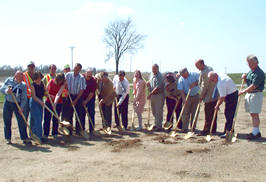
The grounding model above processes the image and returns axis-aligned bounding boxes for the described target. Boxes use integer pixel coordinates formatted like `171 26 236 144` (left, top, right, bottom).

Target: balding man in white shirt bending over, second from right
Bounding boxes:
208 71 238 138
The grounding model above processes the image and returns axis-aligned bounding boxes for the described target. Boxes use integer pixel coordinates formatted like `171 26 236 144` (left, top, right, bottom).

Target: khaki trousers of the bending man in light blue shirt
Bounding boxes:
182 94 199 130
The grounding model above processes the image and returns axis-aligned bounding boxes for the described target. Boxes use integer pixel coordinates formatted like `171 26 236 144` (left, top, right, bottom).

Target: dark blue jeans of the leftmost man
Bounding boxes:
3 101 28 140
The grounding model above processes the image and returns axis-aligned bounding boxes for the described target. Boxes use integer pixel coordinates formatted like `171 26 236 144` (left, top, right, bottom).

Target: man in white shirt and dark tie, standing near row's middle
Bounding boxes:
113 71 129 129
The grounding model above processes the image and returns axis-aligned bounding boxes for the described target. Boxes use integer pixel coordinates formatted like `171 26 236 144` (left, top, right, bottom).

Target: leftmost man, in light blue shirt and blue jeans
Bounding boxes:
0 71 31 144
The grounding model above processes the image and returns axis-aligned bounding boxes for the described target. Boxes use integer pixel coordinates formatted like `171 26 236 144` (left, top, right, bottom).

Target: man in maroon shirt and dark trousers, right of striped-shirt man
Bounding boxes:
80 69 97 133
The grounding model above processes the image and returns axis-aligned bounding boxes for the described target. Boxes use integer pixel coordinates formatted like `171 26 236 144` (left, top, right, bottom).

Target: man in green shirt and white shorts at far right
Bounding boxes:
239 55 265 140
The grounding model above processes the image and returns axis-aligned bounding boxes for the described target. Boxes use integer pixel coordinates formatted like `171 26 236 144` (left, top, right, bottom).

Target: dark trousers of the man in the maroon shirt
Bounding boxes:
80 97 95 132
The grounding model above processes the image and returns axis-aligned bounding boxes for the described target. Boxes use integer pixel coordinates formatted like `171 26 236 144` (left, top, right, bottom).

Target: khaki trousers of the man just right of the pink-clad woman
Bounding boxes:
151 94 164 129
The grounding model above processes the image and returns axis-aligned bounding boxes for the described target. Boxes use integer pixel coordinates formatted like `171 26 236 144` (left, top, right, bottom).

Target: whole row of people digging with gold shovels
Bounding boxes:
0 55 265 144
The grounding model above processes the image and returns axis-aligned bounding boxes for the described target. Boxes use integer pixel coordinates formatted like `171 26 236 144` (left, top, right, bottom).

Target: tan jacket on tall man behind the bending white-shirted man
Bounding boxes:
199 66 218 103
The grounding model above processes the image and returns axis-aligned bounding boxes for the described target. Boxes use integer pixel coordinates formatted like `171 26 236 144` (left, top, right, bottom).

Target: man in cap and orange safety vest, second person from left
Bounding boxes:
23 61 35 119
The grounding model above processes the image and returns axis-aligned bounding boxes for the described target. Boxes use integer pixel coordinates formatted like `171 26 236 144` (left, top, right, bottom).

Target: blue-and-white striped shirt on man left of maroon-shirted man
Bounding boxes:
66 72 86 95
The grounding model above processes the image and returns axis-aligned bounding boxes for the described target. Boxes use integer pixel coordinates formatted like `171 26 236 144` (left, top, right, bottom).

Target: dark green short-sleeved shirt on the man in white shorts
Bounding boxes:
247 67 265 92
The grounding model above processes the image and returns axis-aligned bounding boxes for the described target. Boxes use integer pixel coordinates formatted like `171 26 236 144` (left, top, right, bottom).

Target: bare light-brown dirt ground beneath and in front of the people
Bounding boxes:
0 97 266 182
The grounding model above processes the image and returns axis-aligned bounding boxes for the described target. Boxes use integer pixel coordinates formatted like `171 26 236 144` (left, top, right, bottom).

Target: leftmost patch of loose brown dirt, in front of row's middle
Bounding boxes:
108 139 141 152
